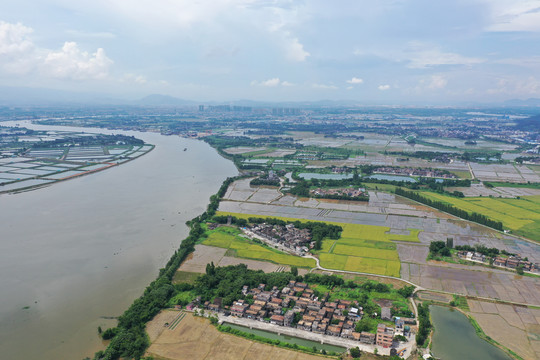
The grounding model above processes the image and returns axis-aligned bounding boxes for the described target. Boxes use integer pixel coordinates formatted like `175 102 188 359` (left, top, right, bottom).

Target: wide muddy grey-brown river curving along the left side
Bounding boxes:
0 121 237 360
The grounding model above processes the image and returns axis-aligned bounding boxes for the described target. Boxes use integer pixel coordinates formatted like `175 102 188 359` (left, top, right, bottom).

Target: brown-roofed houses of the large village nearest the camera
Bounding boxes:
198 281 415 347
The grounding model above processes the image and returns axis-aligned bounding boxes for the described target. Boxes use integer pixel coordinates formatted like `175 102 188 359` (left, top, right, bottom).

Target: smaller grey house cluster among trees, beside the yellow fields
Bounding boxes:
247 223 314 254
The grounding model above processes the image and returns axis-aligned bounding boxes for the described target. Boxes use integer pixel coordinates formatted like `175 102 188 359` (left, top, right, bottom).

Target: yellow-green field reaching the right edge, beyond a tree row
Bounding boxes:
422 192 540 241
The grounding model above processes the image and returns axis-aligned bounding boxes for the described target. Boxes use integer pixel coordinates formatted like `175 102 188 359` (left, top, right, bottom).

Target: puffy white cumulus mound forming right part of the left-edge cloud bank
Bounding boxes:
43 42 113 80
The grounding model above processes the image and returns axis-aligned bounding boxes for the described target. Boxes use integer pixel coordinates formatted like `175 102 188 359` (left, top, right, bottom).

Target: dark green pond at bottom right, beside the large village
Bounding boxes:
429 306 512 360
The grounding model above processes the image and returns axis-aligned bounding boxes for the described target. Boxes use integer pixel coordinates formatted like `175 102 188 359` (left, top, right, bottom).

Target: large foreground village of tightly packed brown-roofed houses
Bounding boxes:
186 281 416 355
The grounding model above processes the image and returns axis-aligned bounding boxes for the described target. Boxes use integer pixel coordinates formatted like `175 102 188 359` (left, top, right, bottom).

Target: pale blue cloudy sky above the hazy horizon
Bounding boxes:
0 0 540 104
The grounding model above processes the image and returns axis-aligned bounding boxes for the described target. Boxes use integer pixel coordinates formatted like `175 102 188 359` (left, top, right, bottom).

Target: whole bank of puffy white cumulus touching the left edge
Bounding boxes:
0 22 113 80
